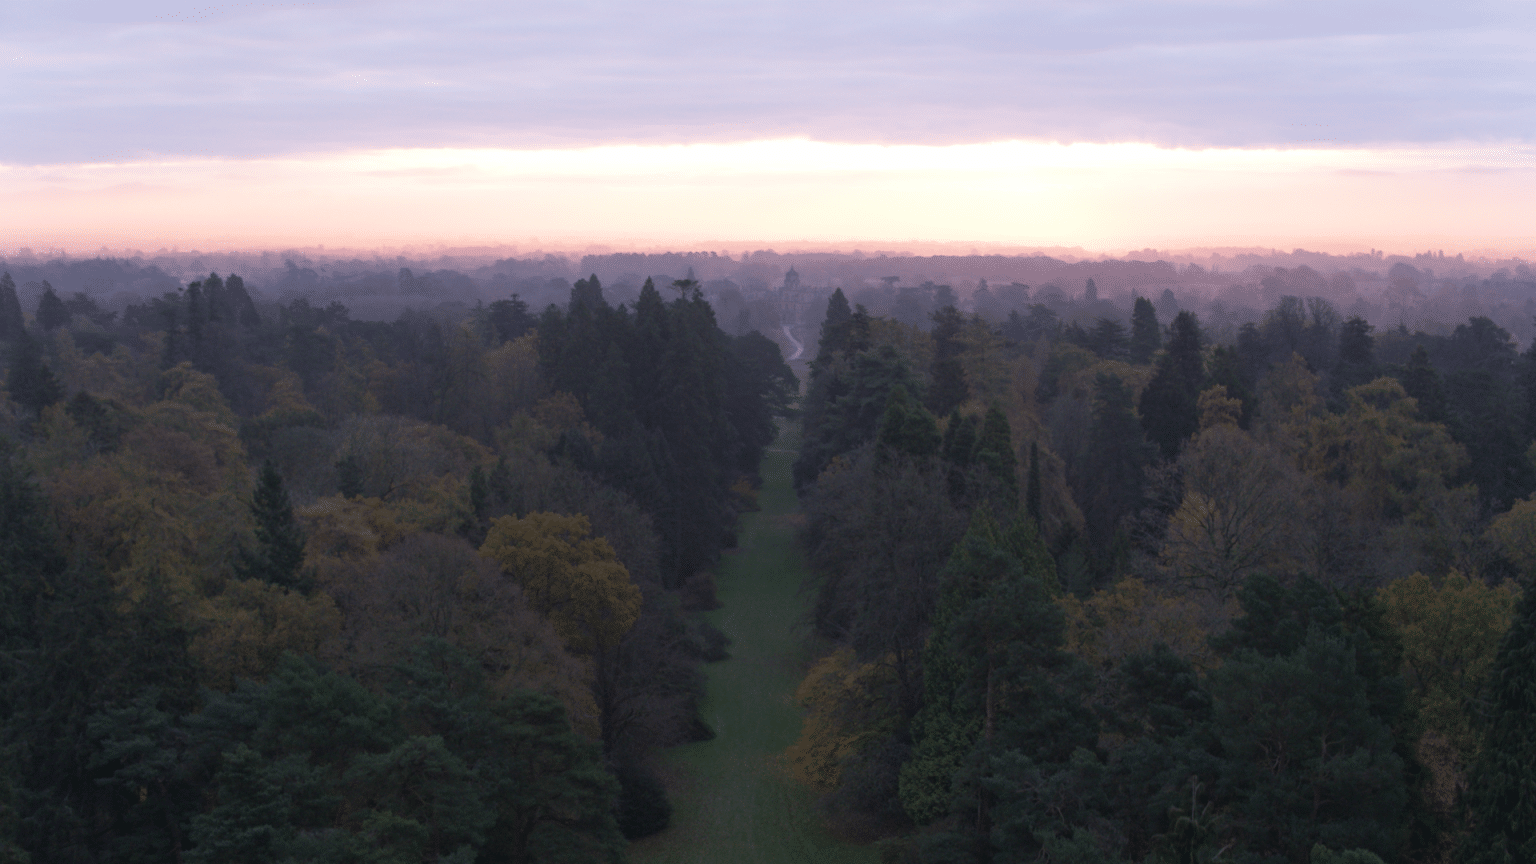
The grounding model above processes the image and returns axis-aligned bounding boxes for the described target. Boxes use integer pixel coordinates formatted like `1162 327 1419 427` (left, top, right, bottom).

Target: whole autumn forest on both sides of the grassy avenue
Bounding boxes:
0 250 1536 864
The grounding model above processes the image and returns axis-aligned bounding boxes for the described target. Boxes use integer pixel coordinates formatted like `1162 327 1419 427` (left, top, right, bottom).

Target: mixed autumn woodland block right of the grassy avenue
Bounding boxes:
788 283 1536 864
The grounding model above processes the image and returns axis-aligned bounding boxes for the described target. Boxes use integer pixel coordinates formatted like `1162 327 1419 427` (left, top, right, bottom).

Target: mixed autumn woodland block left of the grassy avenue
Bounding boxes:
0 268 797 864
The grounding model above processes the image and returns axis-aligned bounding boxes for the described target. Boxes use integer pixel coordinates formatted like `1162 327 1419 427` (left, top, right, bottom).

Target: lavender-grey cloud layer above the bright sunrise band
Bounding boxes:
0 0 1536 246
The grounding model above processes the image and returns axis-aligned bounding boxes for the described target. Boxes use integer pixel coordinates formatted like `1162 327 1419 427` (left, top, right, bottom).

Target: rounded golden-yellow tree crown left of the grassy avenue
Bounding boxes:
481 513 641 653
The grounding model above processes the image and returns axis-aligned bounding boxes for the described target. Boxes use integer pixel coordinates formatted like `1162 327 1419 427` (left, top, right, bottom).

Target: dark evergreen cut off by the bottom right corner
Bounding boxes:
1459 581 1536 864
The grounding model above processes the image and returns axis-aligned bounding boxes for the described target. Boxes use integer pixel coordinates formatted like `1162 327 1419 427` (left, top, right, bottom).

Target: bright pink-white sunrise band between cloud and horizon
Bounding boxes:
12 138 1536 252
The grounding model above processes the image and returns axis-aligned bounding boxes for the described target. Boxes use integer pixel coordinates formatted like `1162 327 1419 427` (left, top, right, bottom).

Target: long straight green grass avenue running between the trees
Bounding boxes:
630 441 879 864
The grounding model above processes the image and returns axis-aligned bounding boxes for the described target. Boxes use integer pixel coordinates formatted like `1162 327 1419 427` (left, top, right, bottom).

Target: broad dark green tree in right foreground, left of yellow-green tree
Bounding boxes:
1210 575 1412 861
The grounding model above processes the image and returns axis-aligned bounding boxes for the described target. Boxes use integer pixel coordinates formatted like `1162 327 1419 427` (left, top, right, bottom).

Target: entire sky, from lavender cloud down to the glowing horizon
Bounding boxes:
0 0 1536 252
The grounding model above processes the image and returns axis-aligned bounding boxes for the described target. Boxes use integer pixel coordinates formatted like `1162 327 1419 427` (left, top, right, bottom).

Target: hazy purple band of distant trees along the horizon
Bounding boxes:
0 249 1536 347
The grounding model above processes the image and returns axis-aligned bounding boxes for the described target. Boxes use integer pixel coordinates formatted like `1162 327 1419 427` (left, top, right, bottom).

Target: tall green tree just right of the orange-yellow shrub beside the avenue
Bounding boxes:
902 510 1104 861
